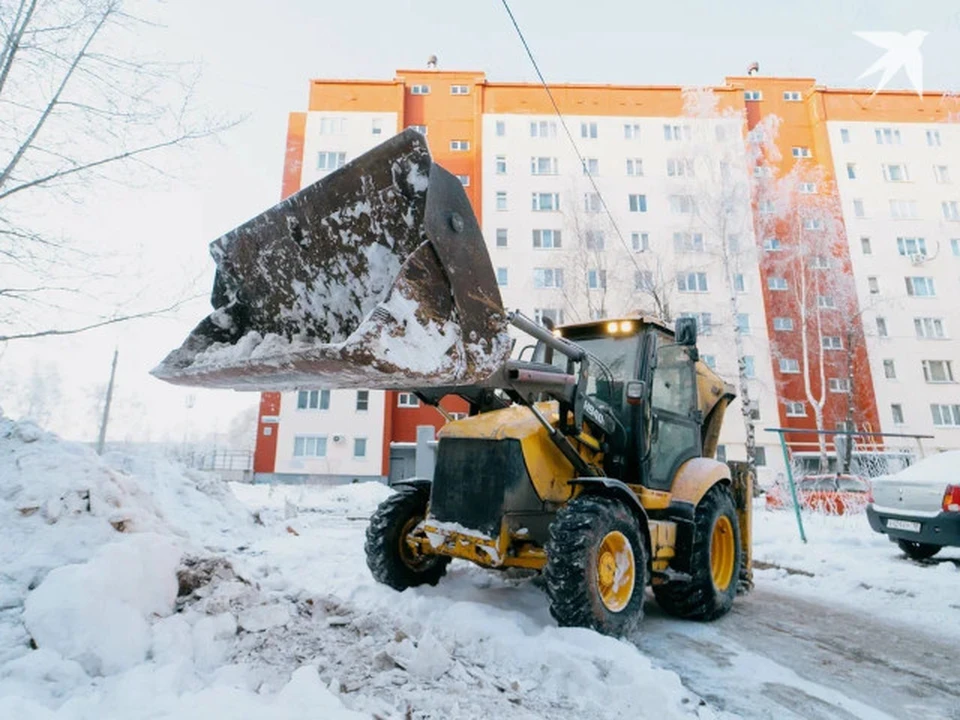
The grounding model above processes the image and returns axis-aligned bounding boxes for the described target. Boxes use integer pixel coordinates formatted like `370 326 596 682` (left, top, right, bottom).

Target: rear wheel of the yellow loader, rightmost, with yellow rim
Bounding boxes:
653 485 742 620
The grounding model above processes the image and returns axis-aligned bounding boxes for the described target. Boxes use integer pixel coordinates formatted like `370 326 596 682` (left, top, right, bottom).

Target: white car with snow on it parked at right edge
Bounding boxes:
867 450 960 560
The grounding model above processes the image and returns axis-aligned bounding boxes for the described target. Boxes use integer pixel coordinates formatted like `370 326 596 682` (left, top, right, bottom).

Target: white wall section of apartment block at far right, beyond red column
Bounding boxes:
828 122 960 450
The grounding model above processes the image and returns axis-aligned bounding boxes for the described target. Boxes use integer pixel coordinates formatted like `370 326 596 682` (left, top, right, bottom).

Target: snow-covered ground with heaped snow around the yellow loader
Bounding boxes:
0 417 960 720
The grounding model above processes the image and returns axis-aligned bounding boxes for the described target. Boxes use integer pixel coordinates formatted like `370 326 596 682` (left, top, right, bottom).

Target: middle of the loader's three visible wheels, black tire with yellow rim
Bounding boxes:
543 496 647 637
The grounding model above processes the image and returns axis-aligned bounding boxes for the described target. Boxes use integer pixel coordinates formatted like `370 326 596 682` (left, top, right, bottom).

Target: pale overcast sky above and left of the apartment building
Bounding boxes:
0 0 960 439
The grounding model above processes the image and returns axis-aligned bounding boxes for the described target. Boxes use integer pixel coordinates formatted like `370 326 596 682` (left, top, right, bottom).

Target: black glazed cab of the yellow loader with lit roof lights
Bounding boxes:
533 317 702 490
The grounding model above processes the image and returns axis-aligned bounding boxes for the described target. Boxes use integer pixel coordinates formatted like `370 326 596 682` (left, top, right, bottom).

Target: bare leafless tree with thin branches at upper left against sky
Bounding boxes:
0 0 228 341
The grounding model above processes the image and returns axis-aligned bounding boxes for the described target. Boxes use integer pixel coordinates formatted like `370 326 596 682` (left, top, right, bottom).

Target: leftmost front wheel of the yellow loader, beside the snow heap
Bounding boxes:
364 487 450 590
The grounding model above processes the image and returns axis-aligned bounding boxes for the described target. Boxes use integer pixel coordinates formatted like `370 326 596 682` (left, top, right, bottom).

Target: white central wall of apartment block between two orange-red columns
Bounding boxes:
481 114 782 482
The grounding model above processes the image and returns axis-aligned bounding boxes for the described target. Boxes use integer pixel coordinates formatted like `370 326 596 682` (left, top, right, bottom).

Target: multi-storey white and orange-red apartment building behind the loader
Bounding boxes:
255 69 960 482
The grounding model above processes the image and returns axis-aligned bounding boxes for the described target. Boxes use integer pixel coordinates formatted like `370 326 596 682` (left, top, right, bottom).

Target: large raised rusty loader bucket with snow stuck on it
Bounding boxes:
152 130 510 390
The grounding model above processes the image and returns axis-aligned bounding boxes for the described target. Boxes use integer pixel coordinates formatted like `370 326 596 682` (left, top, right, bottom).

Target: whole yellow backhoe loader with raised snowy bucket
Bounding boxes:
154 131 752 635
